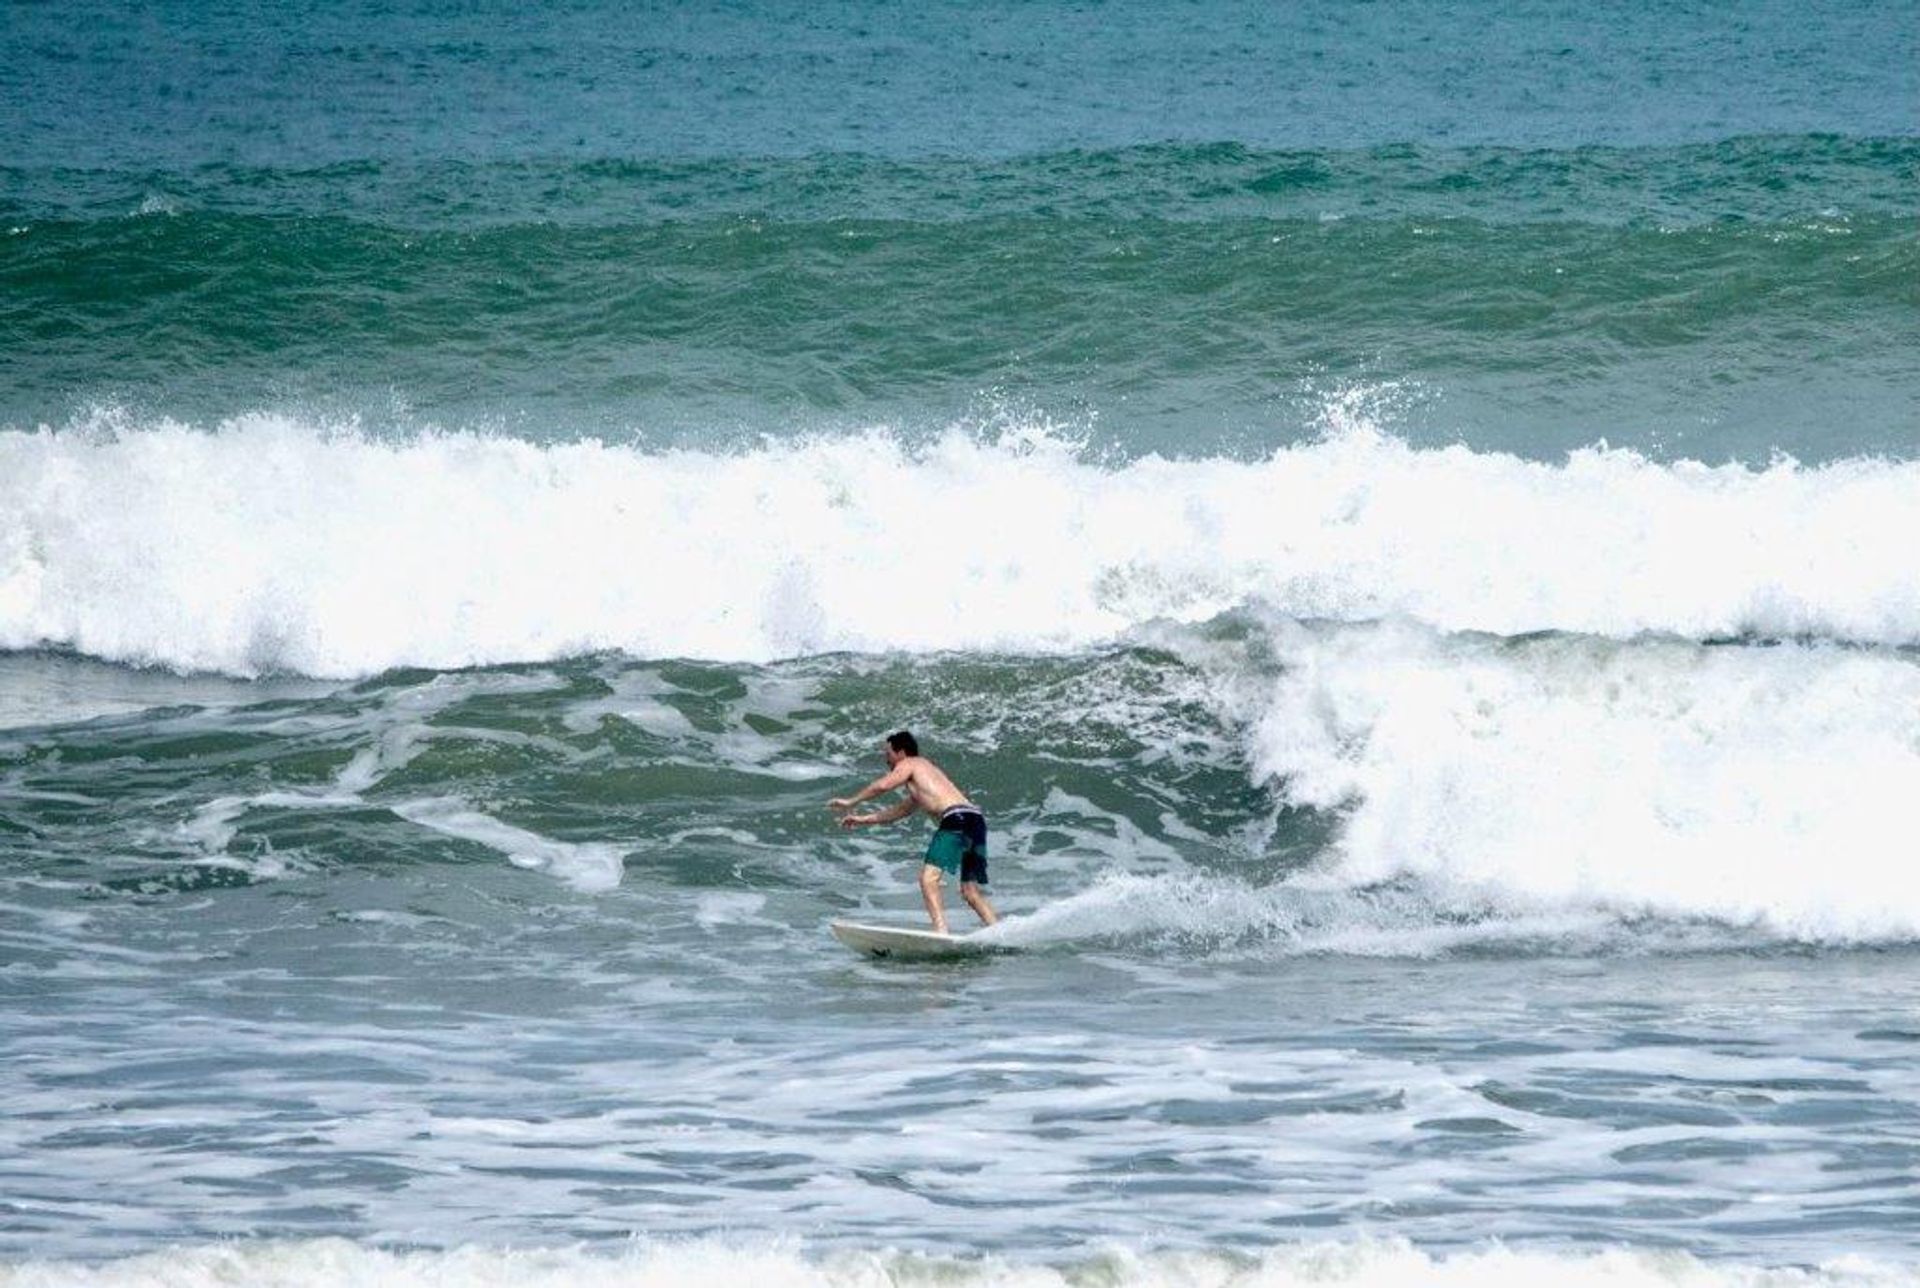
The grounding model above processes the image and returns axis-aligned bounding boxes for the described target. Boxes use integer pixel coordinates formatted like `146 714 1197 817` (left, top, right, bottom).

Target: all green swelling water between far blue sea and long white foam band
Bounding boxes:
0 136 1920 463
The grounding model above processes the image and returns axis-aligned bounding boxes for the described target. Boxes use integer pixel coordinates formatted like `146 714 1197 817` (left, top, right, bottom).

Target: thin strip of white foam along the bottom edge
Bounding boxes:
0 1238 1920 1288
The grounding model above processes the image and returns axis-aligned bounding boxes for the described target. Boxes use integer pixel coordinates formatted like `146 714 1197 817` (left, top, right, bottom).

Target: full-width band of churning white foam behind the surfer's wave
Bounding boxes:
0 415 1920 679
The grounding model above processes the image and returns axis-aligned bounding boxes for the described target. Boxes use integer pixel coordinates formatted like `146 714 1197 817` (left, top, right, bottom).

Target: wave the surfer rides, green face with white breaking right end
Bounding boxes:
0 614 1920 960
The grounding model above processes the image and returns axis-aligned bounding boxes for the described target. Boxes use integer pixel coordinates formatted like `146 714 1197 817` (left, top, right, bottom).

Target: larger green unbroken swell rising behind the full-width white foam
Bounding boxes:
11 196 1920 370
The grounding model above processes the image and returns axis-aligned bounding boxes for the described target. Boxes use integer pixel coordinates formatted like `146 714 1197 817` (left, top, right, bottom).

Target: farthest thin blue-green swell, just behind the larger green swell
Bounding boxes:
0 134 1920 228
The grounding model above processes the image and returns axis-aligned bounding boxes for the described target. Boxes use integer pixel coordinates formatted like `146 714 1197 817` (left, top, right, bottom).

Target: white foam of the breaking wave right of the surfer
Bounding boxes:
1235 622 1920 942
